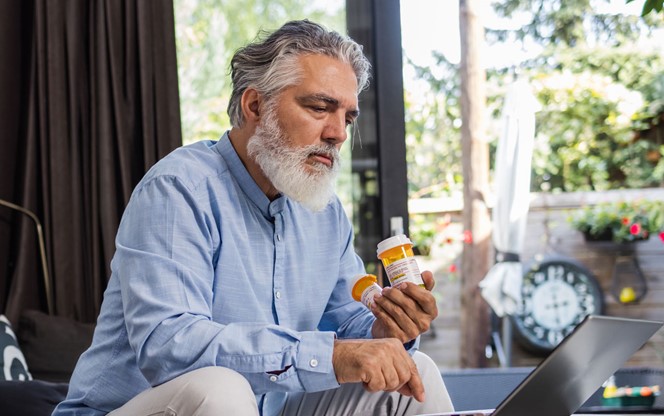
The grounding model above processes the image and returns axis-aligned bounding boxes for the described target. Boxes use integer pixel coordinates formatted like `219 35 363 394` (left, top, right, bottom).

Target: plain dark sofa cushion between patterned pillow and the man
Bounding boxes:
17 310 94 382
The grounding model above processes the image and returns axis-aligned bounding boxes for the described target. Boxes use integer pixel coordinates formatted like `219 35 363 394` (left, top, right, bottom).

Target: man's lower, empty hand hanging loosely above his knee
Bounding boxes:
332 338 424 402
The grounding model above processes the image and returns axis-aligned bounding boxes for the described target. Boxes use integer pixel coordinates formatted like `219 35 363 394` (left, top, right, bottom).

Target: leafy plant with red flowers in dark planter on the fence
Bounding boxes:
569 200 664 243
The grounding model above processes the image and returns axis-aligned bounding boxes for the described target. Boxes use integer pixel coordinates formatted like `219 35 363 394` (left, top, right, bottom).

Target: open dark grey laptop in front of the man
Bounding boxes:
420 315 664 416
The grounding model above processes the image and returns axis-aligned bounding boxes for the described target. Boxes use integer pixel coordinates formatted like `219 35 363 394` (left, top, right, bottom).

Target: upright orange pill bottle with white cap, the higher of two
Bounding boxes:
376 234 424 287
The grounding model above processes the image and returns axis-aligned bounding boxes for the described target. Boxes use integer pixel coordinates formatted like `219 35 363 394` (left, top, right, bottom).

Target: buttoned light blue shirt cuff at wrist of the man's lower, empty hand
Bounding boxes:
295 331 339 392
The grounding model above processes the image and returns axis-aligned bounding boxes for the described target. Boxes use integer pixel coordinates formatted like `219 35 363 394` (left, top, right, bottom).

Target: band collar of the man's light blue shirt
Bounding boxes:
214 132 286 219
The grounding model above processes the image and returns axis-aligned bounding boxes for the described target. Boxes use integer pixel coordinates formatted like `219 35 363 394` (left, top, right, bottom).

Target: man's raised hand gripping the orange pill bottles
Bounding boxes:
371 270 438 343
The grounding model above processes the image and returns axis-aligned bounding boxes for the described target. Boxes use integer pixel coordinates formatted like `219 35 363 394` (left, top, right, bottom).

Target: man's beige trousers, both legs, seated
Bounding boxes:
109 352 454 416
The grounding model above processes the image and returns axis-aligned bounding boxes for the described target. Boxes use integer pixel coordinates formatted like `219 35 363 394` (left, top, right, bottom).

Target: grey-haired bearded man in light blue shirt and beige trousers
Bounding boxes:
54 21 451 416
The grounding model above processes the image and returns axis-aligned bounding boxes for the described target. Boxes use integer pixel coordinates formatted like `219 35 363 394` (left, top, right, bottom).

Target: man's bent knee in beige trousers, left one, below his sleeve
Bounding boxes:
174 367 258 415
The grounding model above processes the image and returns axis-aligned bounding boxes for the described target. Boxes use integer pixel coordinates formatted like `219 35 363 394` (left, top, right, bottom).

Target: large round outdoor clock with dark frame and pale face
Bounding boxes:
512 259 603 352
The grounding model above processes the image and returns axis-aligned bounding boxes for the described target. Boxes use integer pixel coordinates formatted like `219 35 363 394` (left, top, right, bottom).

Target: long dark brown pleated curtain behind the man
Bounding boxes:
0 0 182 322
